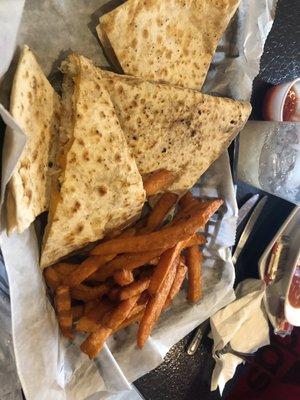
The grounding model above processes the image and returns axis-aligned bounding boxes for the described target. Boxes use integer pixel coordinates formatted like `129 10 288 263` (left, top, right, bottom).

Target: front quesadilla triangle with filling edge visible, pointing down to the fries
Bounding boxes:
41 54 145 267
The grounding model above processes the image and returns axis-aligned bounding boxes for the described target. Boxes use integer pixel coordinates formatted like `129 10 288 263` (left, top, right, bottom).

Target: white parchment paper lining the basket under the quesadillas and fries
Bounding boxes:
0 0 275 400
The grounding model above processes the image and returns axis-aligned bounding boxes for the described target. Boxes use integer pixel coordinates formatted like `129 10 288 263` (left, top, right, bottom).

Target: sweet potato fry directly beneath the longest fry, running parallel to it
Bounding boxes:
90 249 163 282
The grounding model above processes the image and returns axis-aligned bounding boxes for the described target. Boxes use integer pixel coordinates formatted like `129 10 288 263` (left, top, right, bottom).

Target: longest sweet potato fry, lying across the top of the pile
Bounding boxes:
91 200 223 255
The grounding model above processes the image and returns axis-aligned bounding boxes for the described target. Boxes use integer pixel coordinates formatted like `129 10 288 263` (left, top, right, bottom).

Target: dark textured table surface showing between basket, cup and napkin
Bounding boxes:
135 0 300 400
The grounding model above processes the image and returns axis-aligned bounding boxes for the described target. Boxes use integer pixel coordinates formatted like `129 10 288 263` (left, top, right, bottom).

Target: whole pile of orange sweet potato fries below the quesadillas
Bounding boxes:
44 171 223 358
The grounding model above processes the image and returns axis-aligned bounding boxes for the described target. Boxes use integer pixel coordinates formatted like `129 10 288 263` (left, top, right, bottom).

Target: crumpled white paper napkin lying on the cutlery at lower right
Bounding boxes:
210 279 270 394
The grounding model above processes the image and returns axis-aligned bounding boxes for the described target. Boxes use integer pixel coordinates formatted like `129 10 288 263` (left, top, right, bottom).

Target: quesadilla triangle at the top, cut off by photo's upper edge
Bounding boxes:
97 0 240 89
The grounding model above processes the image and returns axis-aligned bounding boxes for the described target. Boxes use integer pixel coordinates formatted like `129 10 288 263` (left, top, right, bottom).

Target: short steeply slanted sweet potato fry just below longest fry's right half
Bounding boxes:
148 240 185 295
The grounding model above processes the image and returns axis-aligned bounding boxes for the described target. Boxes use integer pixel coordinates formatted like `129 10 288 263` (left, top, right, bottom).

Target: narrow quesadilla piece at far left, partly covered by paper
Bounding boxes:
6 46 60 234
